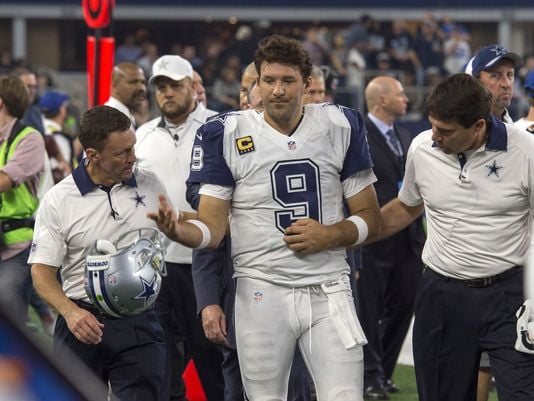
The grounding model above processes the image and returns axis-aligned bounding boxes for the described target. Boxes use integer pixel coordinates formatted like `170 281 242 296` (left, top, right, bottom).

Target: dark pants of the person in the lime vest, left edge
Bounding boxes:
0 247 32 326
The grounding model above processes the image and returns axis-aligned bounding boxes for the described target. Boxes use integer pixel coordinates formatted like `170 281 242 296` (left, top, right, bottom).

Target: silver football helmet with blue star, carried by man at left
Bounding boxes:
85 228 166 317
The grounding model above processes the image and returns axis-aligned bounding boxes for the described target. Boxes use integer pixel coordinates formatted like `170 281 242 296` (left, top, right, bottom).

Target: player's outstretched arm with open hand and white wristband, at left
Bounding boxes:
147 195 230 249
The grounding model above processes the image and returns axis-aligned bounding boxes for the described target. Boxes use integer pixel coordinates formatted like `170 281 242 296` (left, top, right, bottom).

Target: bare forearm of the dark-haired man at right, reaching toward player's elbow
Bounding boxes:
363 198 424 245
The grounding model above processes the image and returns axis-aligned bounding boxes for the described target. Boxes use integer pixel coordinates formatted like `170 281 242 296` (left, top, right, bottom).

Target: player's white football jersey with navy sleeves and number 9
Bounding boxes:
189 104 376 287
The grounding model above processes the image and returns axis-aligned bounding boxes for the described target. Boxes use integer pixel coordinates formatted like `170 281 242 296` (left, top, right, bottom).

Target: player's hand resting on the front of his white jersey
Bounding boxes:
284 219 331 254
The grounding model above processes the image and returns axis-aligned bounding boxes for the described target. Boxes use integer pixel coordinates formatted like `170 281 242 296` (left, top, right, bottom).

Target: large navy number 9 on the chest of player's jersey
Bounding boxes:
271 159 321 232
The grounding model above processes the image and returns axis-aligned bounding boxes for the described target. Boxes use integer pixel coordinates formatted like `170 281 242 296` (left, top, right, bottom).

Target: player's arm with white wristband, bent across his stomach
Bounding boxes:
284 185 380 254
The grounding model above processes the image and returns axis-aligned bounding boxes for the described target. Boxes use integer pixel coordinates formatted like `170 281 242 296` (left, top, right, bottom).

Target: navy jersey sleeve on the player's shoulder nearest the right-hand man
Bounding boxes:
340 107 373 181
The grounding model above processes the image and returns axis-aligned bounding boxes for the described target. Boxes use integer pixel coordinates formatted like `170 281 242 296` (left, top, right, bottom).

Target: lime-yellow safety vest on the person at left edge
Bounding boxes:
0 121 39 245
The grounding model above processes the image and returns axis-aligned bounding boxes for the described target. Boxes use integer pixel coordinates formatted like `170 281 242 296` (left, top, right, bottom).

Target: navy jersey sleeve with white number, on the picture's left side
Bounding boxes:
188 118 235 187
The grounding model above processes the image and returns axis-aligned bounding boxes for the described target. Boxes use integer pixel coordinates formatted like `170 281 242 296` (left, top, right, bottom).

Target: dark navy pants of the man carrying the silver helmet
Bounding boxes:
54 304 165 401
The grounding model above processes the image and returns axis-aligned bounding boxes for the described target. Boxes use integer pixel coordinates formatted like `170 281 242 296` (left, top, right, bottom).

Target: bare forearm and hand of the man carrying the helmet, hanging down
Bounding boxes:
32 263 104 344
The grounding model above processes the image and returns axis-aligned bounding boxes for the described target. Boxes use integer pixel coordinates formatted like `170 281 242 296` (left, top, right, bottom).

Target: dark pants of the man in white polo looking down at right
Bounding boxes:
413 269 534 401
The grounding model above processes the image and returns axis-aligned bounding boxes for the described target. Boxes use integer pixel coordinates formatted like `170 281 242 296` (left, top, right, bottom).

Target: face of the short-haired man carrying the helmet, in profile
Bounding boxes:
91 130 136 186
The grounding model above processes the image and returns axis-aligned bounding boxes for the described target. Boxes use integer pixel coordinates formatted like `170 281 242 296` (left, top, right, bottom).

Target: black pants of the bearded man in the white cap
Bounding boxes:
156 263 224 401
